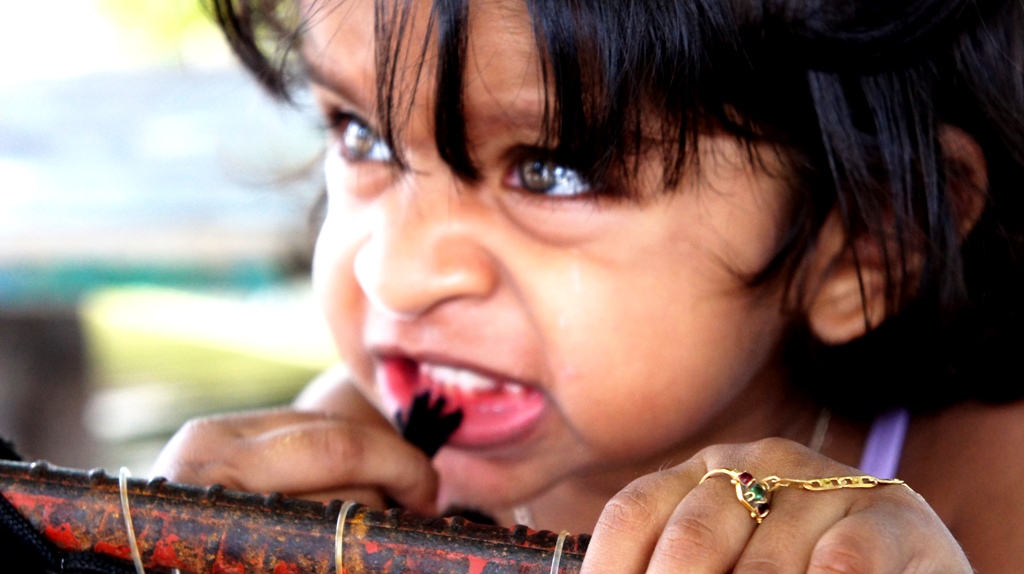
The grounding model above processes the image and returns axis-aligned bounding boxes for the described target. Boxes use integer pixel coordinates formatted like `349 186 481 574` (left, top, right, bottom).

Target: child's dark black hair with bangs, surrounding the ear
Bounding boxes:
212 0 1024 413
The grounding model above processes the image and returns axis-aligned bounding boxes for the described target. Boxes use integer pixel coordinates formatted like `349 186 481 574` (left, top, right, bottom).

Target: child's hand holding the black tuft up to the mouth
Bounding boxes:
152 366 437 513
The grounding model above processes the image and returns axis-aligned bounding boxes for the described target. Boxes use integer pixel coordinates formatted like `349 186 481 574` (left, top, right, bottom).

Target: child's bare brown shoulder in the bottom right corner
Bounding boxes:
901 400 1024 572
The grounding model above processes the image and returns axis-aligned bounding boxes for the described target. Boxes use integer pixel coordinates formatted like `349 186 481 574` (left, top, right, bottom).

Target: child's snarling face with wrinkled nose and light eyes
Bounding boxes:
304 0 786 507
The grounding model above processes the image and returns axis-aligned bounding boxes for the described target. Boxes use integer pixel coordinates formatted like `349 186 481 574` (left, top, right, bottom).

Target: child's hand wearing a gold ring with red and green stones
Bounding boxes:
583 439 972 574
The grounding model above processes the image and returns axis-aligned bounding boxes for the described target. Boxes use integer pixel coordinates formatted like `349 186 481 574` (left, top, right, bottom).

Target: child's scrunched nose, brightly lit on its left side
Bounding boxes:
353 178 498 319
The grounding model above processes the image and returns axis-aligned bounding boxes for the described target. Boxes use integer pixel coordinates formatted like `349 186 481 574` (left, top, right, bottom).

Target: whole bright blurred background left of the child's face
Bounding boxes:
0 0 334 475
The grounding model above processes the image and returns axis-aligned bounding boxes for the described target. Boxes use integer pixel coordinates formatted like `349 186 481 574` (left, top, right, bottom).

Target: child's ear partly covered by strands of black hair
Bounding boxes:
804 126 988 345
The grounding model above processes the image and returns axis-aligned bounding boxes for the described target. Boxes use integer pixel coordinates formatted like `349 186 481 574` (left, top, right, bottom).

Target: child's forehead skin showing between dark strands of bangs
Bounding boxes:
302 0 548 131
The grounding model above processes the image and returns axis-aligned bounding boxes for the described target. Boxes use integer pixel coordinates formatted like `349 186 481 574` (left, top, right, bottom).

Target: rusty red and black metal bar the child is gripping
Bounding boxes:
0 461 589 574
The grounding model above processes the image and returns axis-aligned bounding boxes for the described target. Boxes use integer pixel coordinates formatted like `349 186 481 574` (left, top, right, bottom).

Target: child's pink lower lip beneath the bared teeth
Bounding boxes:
378 358 547 448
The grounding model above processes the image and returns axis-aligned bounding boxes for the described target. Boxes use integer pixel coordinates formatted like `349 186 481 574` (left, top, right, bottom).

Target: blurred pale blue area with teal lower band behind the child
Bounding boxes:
0 68 321 306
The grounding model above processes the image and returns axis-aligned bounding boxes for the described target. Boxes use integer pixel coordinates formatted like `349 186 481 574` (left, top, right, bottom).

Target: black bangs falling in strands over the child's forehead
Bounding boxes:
366 0 753 195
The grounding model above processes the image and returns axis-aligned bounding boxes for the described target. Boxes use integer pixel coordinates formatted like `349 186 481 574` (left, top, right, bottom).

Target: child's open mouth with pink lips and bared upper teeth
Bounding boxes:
378 357 547 448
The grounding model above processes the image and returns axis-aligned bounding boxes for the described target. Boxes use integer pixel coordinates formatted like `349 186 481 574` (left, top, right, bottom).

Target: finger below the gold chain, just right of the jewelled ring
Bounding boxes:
733 489 851 574
